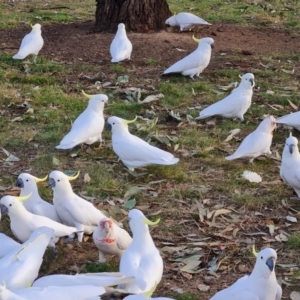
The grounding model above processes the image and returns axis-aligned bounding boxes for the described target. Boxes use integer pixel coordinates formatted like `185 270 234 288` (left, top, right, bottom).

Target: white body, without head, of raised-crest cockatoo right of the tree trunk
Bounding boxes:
164 50 210 74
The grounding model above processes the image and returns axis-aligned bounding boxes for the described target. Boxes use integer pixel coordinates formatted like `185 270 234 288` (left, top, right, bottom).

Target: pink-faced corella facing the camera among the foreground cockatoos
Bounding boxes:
93 218 132 262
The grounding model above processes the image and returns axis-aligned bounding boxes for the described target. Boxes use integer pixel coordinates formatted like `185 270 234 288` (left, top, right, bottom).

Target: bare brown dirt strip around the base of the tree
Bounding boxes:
0 21 300 71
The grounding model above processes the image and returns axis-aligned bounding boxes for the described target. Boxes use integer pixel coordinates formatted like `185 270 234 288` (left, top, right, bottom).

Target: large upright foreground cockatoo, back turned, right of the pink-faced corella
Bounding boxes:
120 209 164 294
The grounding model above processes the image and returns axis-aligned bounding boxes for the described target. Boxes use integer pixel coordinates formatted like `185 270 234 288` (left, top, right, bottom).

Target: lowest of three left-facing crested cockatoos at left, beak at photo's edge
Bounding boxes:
0 195 77 248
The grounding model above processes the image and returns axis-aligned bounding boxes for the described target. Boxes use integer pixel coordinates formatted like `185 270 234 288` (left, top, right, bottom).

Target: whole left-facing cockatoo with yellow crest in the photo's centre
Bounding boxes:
107 117 179 170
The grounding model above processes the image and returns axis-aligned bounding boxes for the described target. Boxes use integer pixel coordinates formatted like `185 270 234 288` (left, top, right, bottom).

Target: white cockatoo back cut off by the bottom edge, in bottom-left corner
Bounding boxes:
0 285 105 300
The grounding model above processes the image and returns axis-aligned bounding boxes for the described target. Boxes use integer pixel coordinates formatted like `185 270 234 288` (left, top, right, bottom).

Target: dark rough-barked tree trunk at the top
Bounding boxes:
95 0 171 32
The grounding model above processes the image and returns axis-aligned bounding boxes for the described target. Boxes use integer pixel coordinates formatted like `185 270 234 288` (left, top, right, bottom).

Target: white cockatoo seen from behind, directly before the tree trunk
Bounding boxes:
110 23 132 62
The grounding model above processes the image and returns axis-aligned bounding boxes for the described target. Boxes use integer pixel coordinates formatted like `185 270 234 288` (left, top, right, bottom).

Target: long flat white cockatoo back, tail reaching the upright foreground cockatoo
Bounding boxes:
32 272 134 287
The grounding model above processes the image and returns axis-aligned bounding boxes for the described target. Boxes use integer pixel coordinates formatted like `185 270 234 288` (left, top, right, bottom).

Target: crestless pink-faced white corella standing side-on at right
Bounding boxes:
225 116 276 163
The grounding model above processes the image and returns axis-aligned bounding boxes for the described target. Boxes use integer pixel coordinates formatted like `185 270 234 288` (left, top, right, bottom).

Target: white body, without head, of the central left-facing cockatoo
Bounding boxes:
112 134 179 167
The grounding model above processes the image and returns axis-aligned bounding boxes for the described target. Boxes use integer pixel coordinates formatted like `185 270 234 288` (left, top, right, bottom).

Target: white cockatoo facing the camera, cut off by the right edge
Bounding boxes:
280 136 300 198
